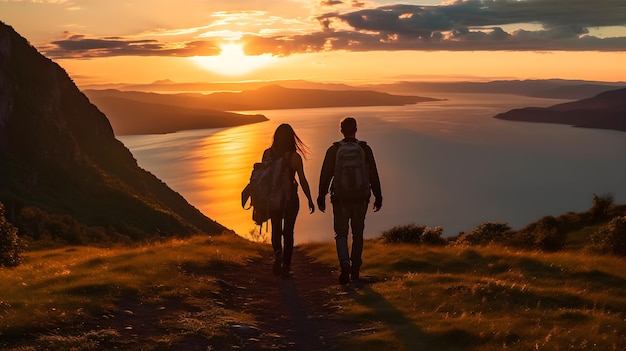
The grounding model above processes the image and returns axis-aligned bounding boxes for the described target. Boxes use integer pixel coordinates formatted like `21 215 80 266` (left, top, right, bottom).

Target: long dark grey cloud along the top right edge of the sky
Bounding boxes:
331 0 626 33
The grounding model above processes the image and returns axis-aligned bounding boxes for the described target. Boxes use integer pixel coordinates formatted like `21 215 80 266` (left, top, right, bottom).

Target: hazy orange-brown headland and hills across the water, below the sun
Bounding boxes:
84 84 437 135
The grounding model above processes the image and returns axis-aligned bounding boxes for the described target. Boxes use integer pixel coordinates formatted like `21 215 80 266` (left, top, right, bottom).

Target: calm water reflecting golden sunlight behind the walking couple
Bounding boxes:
119 94 626 243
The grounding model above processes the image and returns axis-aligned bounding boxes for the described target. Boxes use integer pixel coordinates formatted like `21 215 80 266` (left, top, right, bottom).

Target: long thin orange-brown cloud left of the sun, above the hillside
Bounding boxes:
40 33 220 58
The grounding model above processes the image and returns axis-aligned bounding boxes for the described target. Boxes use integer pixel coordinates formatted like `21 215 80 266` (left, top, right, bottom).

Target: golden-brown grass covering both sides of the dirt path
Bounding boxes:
0 235 626 351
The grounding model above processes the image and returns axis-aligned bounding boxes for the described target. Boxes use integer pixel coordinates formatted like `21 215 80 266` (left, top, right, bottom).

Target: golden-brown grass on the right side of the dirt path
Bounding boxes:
306 240 626 350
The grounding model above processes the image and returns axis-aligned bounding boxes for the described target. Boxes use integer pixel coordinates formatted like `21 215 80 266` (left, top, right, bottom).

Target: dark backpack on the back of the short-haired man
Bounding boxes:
333 140 370 201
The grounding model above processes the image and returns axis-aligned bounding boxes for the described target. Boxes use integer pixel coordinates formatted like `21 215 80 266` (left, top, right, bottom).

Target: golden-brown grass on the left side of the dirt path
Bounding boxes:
0 235 266 351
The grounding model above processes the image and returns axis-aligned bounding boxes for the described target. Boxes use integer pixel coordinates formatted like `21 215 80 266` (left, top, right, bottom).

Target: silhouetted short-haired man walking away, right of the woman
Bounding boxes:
317 117 383 285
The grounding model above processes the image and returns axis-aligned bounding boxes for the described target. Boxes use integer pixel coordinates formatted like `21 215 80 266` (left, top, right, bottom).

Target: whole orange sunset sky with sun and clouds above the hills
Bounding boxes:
0 0 626 86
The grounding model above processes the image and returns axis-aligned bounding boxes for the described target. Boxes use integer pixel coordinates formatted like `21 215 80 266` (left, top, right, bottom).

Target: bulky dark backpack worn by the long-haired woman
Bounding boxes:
241 153 294 225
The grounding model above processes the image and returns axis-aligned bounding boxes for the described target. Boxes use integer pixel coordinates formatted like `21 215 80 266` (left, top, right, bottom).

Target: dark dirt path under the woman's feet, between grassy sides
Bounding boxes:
221 248 355 351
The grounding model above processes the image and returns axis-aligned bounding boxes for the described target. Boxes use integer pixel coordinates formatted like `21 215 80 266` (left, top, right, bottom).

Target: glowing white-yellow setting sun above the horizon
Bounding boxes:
192 43 276 76
